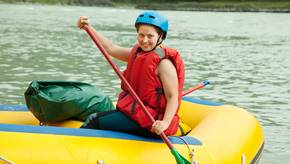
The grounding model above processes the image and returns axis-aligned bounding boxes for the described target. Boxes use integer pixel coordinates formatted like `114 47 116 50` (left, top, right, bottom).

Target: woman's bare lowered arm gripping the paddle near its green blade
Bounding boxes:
152 59 178 134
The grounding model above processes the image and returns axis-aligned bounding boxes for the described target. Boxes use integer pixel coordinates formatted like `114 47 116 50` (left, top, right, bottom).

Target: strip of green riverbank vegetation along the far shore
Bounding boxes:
0 0 290 12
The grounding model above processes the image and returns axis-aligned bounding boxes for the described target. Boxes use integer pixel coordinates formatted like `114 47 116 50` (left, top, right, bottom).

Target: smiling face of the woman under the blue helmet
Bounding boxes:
137 24 159 51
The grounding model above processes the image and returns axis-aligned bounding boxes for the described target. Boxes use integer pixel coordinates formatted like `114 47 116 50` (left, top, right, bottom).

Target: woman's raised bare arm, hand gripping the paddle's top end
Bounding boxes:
77 16 131 62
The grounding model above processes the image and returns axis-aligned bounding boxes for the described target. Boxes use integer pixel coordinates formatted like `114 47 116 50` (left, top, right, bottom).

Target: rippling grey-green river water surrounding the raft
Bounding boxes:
0 4 290 164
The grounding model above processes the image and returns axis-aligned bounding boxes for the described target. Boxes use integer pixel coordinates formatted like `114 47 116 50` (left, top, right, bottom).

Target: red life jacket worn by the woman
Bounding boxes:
117 45 184 135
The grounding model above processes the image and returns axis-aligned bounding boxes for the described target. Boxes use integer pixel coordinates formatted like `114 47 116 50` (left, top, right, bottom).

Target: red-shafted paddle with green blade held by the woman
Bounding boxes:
83 25 191 164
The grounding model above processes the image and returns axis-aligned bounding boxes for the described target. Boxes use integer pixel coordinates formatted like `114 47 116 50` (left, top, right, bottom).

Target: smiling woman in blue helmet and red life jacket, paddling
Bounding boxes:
77 11 190 137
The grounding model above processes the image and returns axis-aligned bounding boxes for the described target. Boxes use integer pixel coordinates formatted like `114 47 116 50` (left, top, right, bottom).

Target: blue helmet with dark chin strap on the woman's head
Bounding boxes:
135 11 168 40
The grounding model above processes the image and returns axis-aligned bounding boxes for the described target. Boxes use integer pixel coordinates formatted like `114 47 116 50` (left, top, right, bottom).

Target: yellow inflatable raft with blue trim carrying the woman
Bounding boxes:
0 97 264 164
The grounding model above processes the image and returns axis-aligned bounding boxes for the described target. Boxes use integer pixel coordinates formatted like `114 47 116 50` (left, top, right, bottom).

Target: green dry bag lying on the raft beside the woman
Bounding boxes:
24 81 114 123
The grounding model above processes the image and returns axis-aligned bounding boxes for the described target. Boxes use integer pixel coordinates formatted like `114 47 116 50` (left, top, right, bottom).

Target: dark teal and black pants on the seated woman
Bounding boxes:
81 110 160 138
